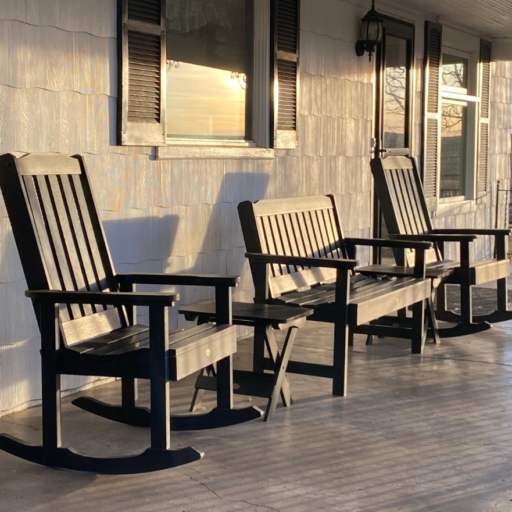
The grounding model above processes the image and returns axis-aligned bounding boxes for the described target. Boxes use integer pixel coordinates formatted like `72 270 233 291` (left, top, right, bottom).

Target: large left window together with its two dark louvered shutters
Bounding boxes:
118 0 299 148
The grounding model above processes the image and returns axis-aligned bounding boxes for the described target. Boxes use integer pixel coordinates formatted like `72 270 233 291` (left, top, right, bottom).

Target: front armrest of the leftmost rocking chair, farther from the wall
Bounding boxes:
25 290 180 307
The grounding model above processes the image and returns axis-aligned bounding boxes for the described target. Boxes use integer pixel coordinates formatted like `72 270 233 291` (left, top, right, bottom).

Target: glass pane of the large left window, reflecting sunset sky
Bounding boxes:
166 0 247 139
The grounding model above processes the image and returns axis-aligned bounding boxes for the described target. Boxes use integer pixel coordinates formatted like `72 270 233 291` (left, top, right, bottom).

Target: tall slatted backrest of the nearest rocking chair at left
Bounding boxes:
0 155 127 345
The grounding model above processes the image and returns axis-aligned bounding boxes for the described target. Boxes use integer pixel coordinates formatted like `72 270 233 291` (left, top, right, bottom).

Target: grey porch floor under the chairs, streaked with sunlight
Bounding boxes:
0 322 512 512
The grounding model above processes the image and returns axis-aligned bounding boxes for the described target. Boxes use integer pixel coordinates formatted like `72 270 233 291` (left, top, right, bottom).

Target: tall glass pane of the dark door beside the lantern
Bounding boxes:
383 36 407 148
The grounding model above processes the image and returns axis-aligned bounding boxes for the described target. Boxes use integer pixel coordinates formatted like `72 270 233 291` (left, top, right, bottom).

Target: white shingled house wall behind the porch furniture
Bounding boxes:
0 0 512 415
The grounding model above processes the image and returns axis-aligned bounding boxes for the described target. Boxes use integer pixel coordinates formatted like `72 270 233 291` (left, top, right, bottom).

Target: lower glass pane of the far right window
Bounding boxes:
441 102 468 197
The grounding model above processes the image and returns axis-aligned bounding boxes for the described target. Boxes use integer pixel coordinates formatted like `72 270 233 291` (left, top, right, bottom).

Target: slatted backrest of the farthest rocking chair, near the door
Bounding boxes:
371 156 442 263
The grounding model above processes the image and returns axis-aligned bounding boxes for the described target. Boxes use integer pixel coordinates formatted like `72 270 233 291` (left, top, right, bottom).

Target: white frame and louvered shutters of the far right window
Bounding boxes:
422 21 491 212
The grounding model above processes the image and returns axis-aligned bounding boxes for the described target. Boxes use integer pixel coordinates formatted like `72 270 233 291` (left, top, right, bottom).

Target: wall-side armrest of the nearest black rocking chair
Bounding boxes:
116 272 240 287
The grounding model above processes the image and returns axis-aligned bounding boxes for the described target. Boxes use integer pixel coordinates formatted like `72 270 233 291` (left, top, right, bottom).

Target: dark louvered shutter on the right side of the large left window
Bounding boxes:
273 0 300 148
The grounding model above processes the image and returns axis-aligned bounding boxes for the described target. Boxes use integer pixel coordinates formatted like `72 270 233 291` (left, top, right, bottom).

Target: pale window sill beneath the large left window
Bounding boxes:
156 141 274 160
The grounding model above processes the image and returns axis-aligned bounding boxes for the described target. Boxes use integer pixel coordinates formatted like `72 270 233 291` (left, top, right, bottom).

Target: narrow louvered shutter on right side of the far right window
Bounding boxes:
477 39 492 195
